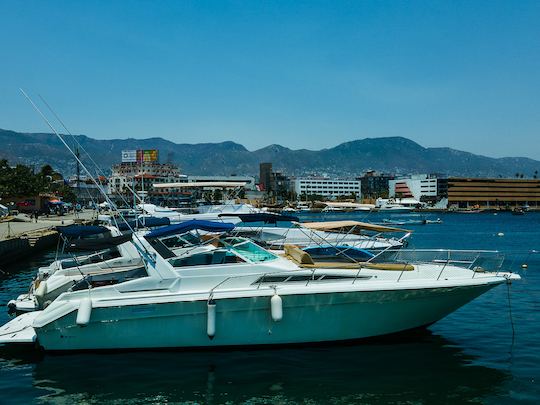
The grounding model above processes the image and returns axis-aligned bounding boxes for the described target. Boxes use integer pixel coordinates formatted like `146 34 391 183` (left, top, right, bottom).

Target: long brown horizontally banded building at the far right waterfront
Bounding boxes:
448 178 540 209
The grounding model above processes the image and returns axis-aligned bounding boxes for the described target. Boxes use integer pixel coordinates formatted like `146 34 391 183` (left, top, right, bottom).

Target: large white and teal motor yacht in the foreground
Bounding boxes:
0 221 519 351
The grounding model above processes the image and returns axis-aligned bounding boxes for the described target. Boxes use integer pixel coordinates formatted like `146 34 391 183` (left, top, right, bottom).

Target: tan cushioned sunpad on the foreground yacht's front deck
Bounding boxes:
283 244 414 271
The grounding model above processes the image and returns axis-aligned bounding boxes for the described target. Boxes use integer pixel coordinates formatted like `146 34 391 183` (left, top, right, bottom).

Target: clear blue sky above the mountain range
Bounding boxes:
0 0 540 160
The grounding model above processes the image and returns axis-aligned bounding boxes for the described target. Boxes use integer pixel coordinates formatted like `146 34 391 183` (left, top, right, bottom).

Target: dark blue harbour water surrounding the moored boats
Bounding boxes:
0 213 540 404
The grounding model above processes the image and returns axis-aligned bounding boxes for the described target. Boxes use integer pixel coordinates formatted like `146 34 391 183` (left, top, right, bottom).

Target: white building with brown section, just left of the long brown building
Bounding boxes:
388 174 444 202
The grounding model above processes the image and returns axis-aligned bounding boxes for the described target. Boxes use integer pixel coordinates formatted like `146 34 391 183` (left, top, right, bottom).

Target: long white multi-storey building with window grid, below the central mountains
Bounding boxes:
291 177 361 199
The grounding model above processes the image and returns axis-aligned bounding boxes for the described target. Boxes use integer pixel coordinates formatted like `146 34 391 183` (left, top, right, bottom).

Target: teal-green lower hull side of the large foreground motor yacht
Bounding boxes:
35 284 496 351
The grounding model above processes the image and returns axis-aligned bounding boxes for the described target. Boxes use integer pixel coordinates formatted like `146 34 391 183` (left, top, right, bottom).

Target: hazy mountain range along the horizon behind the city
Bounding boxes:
0 129 540 177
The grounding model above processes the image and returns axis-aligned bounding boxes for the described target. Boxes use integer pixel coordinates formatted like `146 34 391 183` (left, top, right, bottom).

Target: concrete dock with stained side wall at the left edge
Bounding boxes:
0 210 97 268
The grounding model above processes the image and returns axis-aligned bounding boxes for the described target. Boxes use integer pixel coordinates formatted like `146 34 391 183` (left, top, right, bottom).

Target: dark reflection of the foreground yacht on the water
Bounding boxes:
3 331 508 404
